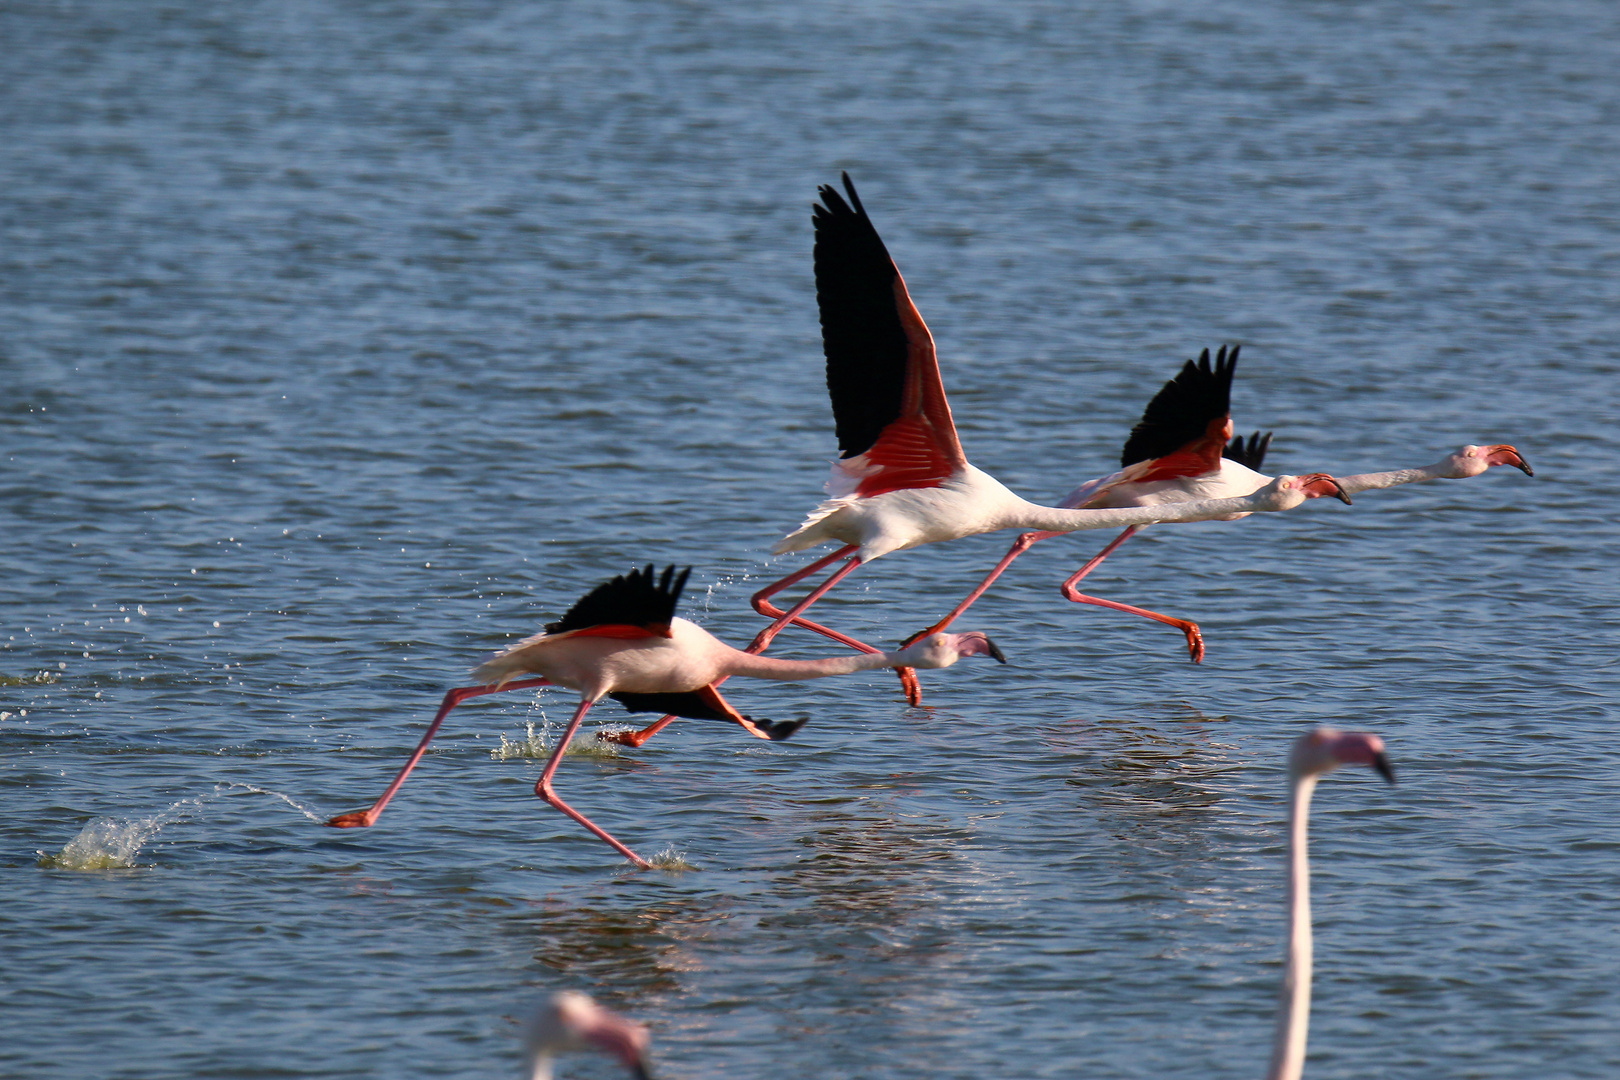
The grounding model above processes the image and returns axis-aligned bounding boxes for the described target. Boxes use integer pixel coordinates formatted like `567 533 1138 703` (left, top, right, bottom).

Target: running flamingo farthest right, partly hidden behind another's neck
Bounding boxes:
902 345 1536 704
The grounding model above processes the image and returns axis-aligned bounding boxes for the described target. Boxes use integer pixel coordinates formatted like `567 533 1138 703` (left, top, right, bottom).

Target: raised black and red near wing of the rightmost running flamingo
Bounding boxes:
1119 345 1243 479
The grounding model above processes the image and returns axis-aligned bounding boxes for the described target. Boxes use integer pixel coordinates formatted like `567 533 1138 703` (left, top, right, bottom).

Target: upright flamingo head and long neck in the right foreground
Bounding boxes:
1265 727 1395 1080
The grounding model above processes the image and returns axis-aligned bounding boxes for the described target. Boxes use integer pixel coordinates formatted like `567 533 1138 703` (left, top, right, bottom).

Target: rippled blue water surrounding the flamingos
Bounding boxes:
0 0 1620 1078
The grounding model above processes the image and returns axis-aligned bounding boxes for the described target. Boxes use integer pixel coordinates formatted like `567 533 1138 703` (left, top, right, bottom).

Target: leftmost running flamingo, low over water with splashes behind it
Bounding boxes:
326 565 1006 870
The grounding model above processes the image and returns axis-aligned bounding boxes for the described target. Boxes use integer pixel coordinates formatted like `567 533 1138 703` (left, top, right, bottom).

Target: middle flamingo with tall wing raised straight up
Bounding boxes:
729 173 1345 696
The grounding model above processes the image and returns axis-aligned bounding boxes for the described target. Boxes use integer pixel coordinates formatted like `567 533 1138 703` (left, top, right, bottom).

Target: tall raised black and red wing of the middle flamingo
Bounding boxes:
813 173 967 495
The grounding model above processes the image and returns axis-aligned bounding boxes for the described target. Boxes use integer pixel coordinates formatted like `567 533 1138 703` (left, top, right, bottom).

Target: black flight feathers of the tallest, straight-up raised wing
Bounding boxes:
812 173 907 458
